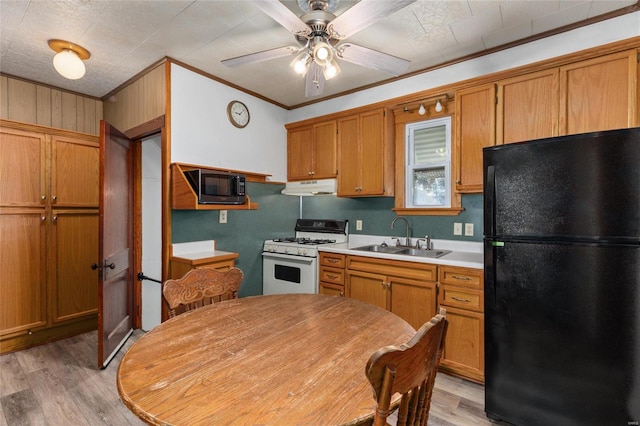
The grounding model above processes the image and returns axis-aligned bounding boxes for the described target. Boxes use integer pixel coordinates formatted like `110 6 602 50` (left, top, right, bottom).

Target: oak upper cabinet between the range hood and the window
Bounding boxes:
338 108 394 197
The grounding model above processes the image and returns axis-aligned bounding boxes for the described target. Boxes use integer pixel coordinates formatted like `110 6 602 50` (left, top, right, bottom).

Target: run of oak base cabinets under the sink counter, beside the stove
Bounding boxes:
338 252 484 383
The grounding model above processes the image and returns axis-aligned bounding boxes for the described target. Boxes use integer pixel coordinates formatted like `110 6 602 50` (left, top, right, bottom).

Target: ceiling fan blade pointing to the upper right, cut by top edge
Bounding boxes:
329 0 416 39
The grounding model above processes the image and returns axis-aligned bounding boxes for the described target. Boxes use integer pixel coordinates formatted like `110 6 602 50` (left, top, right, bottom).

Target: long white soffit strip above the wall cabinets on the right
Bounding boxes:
287 12 640 123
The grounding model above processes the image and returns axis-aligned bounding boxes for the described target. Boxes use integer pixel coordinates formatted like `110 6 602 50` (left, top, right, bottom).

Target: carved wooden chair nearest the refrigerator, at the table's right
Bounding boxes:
366 309 448 426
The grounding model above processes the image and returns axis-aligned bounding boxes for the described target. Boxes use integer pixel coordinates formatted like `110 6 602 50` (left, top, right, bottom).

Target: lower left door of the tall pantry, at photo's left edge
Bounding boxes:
0 208 47 337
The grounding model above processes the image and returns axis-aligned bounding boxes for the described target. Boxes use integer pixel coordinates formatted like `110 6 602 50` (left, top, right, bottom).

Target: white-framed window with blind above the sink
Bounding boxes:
405 117 451 208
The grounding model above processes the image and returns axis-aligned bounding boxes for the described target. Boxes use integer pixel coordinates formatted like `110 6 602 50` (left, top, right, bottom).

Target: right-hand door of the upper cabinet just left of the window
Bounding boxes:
360 110 385 195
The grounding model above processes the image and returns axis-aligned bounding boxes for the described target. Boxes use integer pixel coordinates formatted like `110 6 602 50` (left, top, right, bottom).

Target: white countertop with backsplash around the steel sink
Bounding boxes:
318 234 484 269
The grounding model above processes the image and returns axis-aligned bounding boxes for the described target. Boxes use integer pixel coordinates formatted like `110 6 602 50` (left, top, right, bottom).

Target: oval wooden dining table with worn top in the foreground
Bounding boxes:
117 294 415 425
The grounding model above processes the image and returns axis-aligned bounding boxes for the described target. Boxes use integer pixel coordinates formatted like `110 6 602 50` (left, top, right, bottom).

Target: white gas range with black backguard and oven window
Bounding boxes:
262 219 349 294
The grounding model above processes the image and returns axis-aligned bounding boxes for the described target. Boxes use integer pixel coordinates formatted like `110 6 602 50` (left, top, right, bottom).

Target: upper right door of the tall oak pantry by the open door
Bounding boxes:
51 136 100 208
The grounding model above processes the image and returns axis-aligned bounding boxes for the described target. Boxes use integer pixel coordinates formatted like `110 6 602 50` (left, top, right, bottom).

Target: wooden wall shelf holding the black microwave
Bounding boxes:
171 163 260 210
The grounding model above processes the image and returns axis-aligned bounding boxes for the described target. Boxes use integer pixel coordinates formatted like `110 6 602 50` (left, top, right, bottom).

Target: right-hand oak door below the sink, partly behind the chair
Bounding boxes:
389 278 436 330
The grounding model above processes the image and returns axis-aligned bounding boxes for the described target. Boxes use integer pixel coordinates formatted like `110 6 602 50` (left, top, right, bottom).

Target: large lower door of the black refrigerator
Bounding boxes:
485 241 640 426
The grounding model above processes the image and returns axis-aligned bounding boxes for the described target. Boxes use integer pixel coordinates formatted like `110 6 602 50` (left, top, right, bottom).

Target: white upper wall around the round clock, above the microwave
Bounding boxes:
171 64 287 182
